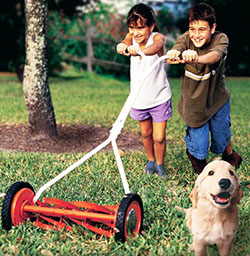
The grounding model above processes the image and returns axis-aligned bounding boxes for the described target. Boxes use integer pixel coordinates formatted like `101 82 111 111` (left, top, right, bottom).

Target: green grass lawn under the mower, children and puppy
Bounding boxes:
0 71 250 256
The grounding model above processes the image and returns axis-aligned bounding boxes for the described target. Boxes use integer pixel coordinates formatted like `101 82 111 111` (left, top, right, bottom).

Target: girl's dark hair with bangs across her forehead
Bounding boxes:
127 3 159 32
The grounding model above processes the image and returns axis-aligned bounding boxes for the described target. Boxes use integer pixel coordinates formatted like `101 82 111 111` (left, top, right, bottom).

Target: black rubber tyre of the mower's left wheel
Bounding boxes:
2 181 34 230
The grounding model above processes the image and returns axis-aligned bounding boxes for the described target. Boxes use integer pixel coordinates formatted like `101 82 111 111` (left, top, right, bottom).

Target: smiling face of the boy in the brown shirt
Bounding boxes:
188 20 216 48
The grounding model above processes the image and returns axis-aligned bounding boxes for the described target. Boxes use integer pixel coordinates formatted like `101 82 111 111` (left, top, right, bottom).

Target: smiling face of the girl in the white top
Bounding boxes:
128 19 155 48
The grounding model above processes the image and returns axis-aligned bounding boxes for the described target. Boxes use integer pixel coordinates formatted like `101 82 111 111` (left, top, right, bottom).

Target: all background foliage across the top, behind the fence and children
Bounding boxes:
0 0 250 76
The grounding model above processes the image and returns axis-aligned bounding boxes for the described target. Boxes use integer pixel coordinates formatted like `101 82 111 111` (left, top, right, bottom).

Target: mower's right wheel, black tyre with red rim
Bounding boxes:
115 193 143 243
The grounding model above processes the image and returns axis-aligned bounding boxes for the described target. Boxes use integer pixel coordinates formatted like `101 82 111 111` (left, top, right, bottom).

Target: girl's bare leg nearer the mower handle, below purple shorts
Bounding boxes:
139 118 154 162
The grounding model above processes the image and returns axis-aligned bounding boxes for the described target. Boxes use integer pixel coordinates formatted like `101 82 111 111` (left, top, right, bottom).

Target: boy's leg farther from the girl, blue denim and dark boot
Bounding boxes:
210 100 242 169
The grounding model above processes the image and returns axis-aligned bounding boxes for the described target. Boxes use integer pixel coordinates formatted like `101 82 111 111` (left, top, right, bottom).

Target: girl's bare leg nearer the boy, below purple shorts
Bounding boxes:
153 121 167 165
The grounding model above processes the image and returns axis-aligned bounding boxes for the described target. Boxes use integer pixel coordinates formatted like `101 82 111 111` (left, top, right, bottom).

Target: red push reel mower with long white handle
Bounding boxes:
2 53 169 242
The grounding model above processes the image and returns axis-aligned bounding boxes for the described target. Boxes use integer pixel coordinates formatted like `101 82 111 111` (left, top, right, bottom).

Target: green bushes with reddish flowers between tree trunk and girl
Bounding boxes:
48 3 129 76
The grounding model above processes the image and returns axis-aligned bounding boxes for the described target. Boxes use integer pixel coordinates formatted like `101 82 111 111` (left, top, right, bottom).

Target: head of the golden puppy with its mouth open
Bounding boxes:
190 160 243 209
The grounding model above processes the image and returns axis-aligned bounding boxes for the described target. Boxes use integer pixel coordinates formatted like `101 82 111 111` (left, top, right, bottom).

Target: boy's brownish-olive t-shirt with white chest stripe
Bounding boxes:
173 31 230 127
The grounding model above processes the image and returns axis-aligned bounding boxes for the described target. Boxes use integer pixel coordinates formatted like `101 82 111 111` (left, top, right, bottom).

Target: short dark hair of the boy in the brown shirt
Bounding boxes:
188 3 216 28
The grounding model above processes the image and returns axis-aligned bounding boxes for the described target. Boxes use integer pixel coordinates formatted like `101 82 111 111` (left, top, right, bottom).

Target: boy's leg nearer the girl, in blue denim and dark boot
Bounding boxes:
185 123 209 174
